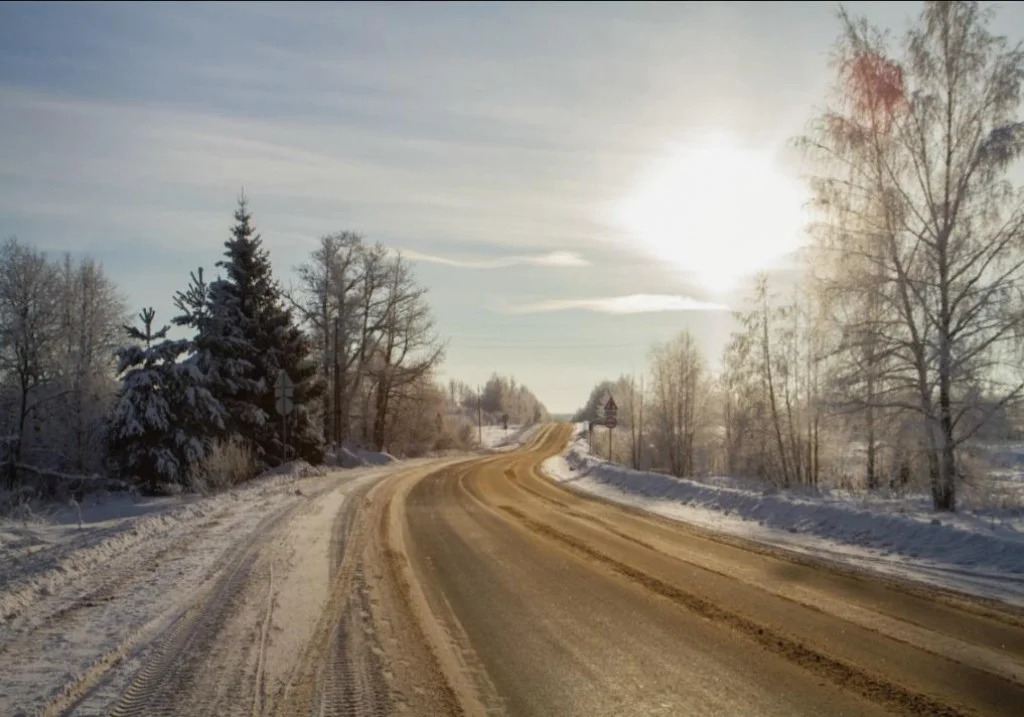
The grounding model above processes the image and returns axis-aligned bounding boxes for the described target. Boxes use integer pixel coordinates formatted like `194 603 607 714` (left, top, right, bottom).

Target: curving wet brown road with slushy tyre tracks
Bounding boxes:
39 426 1024 716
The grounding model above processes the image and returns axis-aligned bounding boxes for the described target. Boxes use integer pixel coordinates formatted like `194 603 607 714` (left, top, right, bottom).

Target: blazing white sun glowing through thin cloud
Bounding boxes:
615 138 806 294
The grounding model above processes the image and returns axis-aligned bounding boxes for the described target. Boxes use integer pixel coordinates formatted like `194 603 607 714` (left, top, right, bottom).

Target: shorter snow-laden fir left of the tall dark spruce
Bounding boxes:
108 308 223 493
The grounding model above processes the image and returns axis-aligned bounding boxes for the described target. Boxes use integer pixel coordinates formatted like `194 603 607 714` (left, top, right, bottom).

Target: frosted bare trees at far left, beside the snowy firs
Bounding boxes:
0 240 126 481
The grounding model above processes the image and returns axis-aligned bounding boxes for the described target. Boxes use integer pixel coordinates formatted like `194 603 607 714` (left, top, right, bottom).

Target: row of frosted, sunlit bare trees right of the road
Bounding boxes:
581 2 1024 510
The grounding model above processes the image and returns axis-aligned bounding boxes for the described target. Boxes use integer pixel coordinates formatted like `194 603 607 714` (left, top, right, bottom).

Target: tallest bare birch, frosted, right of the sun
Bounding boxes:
804 2 1024 510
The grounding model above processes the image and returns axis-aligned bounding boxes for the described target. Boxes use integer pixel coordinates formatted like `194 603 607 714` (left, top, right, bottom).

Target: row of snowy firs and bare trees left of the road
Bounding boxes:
0 198 524 495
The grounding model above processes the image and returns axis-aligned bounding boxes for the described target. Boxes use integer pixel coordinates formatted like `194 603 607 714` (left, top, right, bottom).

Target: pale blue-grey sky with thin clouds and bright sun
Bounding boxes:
6 2 1024 413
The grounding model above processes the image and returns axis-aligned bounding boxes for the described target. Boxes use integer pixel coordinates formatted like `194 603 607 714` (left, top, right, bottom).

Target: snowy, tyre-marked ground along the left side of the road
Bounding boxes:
0 462 407 714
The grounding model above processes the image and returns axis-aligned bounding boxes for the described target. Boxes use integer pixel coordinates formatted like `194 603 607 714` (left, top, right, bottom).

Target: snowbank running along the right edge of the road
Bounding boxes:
544 422 1024 606
